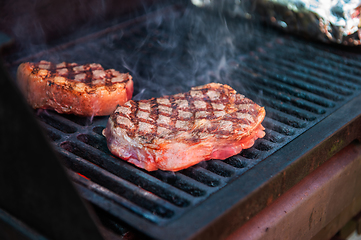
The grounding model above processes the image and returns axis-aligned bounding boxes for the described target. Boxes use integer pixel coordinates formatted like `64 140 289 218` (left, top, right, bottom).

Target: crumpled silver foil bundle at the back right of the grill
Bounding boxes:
192 0 361 46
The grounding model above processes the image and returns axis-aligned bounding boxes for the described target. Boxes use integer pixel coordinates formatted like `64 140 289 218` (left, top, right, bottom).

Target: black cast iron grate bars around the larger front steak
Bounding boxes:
31 24 361 225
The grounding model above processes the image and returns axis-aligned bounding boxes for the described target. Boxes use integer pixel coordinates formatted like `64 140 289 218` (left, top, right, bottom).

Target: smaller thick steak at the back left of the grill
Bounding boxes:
17 61 133 116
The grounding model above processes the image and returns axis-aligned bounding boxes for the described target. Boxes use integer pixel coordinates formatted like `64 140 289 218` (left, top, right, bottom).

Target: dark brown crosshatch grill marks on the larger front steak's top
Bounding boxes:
112 84 260 143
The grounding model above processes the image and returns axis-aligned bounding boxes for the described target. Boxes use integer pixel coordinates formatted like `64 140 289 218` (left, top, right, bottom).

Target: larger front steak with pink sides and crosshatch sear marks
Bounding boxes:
103 83 265 171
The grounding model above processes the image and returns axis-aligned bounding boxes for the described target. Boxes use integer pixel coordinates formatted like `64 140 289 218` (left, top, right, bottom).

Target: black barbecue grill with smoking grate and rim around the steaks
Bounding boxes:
0 2 361 239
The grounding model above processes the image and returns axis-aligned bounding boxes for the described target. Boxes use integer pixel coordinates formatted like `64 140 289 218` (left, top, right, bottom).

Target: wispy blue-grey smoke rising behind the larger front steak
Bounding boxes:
109 0 252 98
